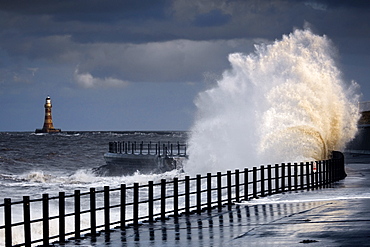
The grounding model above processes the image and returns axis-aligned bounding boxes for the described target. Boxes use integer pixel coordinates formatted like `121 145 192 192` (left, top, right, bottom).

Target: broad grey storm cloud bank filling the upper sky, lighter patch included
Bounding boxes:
0 0 370 85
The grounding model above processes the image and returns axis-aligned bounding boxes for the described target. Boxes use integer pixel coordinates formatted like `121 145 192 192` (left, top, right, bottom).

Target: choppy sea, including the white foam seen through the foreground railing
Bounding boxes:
0 131 187 246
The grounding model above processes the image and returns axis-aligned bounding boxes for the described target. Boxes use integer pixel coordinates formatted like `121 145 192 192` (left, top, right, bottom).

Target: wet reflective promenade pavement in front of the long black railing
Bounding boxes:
65 157 370 247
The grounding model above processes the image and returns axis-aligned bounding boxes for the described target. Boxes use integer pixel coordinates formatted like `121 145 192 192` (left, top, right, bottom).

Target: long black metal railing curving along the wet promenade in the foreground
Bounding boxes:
0 153 346 246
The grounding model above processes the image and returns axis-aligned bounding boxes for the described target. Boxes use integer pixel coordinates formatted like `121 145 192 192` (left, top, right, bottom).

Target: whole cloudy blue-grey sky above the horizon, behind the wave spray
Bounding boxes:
0 0 370 131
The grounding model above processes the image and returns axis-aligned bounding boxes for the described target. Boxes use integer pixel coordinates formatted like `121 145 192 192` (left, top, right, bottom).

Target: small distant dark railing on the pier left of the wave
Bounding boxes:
108 141 186 156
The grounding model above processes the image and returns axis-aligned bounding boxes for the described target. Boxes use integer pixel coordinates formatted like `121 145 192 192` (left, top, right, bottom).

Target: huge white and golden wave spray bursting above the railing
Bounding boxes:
185 30 360 176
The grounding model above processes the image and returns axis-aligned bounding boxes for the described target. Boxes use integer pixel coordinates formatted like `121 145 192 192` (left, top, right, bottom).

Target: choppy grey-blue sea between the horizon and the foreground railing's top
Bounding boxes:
0 131 187 200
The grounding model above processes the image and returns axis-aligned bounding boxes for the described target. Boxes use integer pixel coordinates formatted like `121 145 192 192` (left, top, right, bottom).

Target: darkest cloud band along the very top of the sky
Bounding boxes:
0 0 370 43
